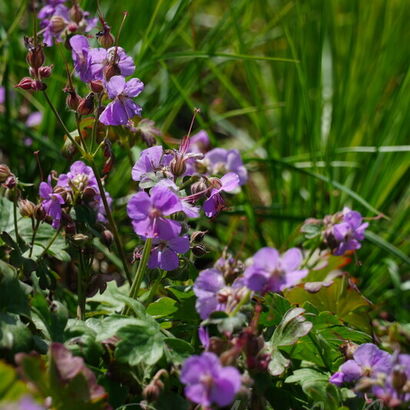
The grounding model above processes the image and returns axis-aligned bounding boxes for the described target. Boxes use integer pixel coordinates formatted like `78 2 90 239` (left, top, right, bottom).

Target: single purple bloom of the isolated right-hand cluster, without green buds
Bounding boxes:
332 208 369 255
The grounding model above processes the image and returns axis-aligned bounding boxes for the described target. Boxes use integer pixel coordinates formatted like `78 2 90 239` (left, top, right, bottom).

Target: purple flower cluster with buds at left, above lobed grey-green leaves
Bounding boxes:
39 161 111 229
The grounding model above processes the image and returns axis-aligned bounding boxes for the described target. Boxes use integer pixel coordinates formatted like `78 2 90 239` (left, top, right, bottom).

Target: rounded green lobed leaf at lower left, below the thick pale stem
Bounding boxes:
115 319 164 366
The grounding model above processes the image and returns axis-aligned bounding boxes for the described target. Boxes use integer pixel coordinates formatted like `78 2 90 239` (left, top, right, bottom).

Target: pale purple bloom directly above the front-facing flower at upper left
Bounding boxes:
90 47 135 80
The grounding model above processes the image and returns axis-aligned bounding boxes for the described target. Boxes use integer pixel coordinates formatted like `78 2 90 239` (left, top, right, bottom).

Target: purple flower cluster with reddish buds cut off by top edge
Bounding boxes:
37 0 98 47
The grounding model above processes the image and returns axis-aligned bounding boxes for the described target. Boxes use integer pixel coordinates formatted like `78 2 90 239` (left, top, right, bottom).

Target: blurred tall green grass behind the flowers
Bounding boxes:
0 0 410 321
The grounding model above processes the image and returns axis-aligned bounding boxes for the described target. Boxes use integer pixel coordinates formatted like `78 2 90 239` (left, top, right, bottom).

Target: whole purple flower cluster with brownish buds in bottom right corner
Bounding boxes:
330 343 410 407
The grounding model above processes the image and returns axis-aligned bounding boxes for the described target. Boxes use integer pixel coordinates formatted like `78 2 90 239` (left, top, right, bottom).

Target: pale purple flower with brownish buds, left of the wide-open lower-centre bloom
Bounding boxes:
194 268 246 319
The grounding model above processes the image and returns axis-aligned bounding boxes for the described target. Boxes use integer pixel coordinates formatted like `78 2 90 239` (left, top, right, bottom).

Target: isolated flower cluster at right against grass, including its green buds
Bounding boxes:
302 207 369 255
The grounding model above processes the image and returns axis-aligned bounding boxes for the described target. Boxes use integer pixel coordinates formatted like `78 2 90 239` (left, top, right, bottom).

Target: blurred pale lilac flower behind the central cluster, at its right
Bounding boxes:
204 148 248 185
